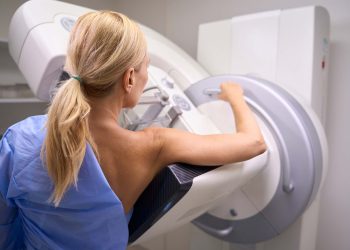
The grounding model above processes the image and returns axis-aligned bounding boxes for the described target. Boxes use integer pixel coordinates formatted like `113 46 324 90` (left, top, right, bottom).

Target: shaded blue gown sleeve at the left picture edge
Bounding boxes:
0 133 22 250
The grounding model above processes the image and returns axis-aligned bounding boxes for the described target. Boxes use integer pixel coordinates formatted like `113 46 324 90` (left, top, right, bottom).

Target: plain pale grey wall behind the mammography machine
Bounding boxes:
0 0 350 250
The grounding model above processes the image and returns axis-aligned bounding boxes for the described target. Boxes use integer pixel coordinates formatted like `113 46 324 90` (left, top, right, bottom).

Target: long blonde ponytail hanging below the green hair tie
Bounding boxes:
42 78 96 206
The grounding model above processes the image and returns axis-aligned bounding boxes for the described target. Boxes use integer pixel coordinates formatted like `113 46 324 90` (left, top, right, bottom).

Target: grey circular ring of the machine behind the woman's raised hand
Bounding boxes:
185 75 327 244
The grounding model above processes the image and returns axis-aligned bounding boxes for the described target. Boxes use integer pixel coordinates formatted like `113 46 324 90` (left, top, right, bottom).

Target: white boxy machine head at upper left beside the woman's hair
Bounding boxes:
9 0 91 100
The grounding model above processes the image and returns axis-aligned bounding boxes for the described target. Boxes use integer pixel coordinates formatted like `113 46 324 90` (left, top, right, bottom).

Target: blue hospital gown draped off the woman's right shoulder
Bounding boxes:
0 116 128 250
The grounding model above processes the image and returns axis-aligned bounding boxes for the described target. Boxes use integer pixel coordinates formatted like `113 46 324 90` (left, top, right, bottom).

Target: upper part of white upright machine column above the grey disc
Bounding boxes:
197 6 330 124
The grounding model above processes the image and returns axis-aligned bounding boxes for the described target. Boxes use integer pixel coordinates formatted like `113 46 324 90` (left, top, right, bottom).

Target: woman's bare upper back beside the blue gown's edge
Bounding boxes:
90 117 159 212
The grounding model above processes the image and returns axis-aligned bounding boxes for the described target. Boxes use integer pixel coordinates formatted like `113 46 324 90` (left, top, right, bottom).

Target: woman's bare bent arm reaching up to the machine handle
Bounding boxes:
151 83 266 169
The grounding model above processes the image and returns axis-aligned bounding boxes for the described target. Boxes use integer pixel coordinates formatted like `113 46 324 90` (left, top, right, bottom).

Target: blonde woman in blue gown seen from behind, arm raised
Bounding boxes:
0 11 265 249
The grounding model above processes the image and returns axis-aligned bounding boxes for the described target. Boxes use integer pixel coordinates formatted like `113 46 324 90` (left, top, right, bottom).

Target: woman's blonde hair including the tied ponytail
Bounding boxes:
42 11 147 206
